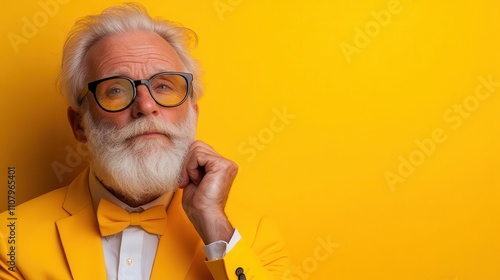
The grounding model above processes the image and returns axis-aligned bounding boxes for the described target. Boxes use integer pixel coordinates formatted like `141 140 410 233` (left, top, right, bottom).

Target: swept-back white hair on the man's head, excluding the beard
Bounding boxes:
58 3 203 111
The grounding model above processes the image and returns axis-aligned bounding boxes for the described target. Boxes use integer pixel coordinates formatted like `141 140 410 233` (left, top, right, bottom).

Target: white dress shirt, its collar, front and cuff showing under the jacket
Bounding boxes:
89 169 241 280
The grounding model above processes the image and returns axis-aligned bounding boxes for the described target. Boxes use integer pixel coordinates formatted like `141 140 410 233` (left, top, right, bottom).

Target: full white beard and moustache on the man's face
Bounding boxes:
83 106 196 202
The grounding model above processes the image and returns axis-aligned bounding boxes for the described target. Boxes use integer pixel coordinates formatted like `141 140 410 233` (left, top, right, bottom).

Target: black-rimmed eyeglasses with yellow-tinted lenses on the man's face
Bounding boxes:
78 72 193 112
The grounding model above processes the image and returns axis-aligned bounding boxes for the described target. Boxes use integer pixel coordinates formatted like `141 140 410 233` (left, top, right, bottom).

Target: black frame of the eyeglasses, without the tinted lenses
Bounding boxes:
78 71 193 113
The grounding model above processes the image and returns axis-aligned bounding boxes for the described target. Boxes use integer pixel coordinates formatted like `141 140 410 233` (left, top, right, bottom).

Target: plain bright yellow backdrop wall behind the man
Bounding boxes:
0 0 500 280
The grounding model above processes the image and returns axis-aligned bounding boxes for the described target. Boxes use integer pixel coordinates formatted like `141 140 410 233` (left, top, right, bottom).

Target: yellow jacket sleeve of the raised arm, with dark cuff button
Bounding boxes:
206 217 290 280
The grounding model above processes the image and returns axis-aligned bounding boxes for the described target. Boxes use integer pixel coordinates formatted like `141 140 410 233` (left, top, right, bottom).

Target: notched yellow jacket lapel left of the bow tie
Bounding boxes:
56 169 106 280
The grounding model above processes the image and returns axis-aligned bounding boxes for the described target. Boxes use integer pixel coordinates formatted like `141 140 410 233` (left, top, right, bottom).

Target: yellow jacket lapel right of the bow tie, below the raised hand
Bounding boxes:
151 190 203 279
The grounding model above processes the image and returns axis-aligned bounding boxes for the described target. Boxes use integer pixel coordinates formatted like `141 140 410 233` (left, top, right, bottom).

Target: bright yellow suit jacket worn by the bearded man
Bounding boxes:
0 169 289 280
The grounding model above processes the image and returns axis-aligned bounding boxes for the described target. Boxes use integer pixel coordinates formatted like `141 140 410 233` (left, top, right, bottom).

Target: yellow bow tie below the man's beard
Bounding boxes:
97 198 167 236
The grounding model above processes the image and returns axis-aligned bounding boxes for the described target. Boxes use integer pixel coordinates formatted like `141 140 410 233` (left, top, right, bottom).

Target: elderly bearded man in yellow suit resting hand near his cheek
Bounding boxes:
0 5 289 280
